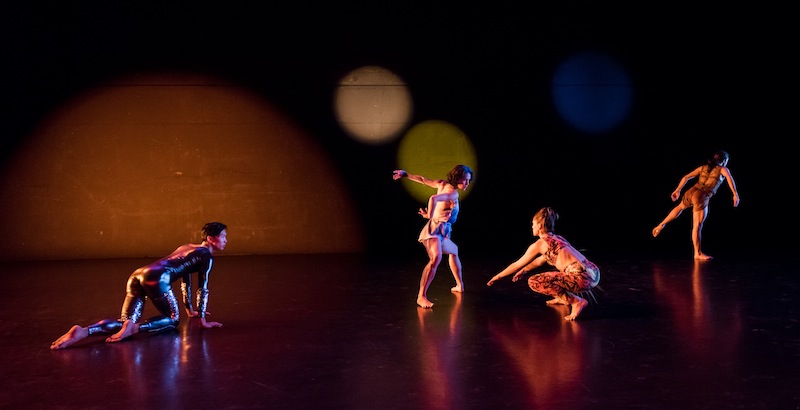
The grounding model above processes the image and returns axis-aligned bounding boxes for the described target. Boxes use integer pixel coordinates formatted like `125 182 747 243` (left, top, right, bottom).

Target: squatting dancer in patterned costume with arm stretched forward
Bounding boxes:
487 208 600 320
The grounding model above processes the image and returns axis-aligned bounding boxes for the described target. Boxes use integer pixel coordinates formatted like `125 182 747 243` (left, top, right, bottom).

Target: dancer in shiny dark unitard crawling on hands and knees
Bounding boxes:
50 222 228 350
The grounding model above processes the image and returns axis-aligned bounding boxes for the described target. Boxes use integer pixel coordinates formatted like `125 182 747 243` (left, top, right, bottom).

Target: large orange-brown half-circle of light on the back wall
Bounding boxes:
0 73 364 259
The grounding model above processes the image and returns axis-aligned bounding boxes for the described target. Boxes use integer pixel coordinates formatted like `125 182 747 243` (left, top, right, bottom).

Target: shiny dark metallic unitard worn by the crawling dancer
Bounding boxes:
89 245 213 335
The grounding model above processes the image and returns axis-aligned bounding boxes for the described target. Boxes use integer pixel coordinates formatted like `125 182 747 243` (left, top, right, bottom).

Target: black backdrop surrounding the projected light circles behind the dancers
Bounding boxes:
2 0 797 255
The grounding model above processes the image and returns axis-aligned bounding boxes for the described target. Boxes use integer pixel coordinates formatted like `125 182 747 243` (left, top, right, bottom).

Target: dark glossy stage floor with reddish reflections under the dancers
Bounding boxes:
0 249 800 410
